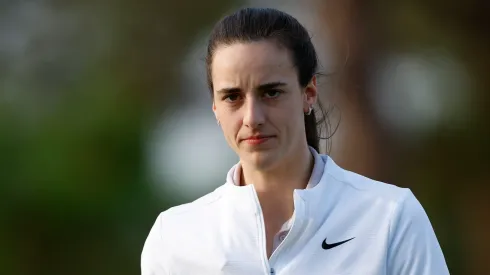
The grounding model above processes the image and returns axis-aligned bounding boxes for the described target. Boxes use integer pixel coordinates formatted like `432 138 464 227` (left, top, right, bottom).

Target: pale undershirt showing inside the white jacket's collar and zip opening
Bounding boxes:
231 147 325 251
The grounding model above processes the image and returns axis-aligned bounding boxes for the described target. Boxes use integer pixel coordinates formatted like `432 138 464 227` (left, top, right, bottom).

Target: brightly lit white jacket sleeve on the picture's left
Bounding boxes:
141 214 170 275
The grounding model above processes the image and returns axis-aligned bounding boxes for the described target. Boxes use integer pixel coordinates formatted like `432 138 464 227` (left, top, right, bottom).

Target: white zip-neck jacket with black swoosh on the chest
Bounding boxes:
141 155 449 275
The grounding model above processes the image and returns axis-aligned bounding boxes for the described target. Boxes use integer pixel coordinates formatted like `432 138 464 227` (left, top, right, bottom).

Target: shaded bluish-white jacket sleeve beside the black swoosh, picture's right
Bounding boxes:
387 191 449 275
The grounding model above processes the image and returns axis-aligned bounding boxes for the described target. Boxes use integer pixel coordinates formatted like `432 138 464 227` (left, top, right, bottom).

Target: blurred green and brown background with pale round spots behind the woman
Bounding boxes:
0 0 490 275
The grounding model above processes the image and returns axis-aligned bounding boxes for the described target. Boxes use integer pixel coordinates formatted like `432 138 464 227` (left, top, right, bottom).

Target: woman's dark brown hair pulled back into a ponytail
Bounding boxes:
206 8 328 152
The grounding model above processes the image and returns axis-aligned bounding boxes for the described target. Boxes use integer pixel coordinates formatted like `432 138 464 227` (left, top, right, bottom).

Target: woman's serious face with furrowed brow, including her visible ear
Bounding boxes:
212 41 317 170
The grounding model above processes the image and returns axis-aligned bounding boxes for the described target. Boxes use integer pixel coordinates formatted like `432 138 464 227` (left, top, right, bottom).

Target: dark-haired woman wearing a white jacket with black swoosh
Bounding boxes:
141 8 449 275
